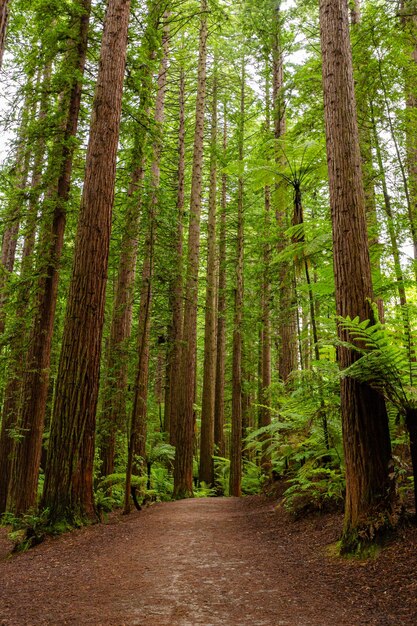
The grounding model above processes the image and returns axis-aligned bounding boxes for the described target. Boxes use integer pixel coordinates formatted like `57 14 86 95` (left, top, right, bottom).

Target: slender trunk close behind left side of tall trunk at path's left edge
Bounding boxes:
164 68 185 445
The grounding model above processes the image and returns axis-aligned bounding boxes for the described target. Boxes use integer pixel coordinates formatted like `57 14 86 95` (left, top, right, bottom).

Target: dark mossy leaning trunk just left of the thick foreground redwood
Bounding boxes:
7 0 91 515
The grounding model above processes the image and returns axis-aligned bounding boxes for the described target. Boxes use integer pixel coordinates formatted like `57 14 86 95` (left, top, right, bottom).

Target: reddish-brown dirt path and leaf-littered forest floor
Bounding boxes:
0 497 417 626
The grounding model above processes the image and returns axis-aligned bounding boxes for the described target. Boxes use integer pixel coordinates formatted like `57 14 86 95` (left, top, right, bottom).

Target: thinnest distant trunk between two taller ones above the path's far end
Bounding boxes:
214 111 227 457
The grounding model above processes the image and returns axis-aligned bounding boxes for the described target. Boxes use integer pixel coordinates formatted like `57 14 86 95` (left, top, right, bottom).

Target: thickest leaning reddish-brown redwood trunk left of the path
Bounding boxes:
42 0 130 523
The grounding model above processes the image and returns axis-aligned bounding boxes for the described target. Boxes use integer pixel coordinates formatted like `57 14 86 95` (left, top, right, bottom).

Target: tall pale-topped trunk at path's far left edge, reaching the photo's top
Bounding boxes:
174 0 208 498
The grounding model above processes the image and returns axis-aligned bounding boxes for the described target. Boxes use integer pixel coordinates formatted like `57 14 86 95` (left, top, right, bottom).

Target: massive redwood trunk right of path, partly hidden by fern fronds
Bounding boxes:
320 0 392 551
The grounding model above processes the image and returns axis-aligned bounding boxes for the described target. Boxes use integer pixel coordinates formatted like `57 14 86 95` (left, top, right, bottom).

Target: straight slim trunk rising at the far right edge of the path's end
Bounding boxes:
229 58 245 496
